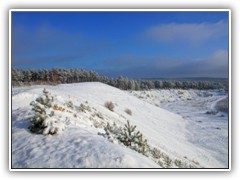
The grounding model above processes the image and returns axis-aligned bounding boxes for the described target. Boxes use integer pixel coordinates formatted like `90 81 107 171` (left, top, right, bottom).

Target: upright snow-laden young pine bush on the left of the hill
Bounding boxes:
29 88 65 135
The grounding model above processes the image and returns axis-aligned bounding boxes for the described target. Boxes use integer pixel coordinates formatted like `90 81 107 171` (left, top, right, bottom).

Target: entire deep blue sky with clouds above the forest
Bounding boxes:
12 11 228 78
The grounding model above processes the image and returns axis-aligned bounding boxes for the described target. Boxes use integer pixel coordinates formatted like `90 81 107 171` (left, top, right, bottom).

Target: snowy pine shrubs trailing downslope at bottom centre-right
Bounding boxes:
99 121 198 168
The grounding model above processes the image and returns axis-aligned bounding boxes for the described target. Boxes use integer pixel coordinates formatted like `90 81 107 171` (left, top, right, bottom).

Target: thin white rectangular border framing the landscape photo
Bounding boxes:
8 8 232 172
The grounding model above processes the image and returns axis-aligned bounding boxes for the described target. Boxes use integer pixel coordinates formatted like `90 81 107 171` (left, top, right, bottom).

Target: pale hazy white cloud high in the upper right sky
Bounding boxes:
145 21 228 43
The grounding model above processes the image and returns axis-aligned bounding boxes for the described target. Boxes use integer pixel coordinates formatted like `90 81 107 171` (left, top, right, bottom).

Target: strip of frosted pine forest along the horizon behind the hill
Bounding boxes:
12 68 228 91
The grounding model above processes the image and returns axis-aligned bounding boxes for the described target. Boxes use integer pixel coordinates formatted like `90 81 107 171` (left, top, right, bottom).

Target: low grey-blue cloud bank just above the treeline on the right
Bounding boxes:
100 50 228 78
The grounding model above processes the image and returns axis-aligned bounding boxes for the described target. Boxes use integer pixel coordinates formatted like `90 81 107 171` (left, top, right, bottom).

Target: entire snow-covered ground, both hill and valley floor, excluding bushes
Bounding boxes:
11 82 228 168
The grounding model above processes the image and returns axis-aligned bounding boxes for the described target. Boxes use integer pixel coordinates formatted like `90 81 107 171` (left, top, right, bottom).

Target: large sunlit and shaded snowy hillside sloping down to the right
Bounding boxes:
12 82 228 168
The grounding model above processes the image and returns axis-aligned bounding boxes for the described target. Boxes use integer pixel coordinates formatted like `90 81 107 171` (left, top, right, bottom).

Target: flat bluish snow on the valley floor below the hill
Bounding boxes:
162 91 228 167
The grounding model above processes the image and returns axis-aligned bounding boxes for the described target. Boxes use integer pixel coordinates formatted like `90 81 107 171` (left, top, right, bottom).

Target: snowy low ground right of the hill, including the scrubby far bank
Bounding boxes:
130 89 228 167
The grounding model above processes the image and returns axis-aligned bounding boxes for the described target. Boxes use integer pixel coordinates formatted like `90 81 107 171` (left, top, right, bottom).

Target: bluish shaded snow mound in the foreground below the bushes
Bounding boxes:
12 127 157 168
